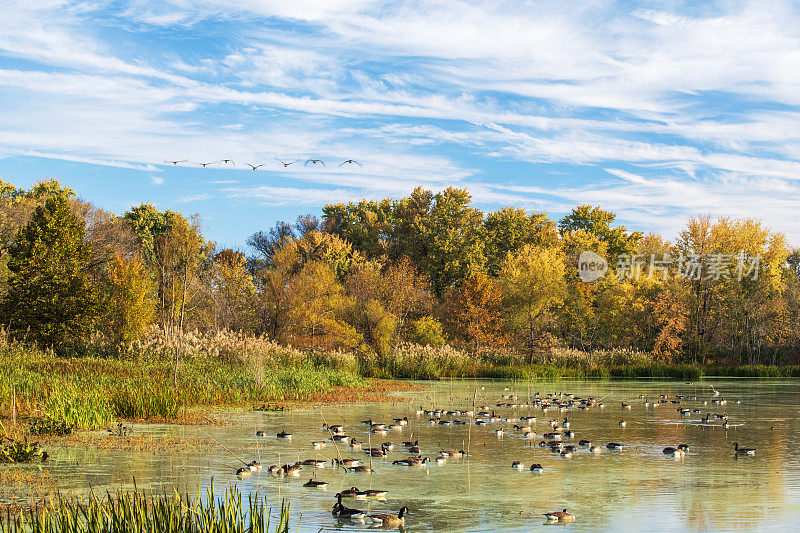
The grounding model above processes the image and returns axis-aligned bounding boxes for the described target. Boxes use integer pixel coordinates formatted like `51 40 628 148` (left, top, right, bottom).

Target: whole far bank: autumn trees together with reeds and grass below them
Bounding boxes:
0 180 800 438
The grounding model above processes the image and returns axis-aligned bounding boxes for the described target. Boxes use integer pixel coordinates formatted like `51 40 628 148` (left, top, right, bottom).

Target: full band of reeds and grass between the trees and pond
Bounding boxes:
0 330 800 437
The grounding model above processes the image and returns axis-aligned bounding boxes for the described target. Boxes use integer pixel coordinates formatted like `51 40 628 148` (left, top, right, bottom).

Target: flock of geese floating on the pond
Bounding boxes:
222 386 756 528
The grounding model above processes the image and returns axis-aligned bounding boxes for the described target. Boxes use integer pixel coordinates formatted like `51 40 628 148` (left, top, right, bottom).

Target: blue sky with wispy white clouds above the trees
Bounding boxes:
0 0 800 247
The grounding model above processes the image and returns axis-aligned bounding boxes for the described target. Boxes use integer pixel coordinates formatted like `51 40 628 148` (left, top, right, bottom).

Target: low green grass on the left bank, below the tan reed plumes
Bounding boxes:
0 344 365 429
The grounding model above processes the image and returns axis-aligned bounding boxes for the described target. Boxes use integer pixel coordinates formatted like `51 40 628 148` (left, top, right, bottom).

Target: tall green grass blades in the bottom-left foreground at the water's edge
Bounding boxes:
0 485 289 533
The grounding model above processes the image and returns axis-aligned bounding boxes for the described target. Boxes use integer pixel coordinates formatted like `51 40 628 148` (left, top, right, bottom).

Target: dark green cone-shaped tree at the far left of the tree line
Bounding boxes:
2 194 97 350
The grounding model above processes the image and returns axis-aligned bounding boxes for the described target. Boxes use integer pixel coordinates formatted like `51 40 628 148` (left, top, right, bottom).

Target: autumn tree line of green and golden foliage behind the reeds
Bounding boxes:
0 181 800 364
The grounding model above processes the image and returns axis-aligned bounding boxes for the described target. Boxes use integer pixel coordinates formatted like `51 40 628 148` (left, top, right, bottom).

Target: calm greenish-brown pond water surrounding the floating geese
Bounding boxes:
6 380 800 532
